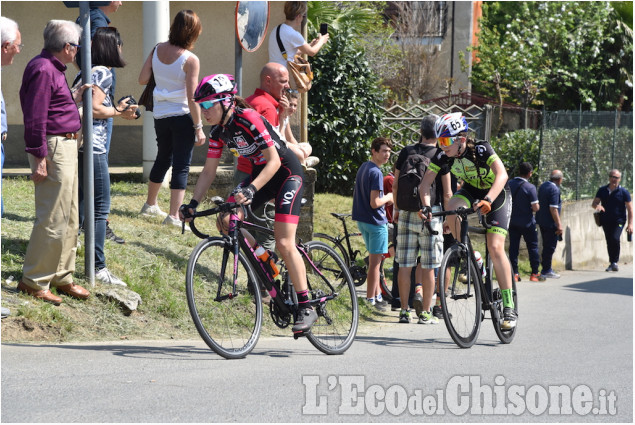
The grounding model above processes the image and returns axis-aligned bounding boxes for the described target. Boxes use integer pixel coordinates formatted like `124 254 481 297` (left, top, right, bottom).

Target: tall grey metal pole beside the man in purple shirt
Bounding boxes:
79 1 95 287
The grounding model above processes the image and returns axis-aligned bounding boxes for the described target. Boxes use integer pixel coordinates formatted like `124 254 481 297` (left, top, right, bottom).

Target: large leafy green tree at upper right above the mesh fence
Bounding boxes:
471 1 633 110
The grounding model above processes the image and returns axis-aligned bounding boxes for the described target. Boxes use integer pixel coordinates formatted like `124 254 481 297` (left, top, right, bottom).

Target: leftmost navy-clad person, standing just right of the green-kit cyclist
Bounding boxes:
508 162 544 282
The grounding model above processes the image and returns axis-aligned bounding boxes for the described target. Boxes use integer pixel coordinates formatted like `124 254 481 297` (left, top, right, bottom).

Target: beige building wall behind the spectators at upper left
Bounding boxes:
2 1 284 168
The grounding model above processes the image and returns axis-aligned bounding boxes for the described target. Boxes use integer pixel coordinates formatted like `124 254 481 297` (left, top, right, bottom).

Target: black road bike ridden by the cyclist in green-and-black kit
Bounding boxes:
426 207 518 348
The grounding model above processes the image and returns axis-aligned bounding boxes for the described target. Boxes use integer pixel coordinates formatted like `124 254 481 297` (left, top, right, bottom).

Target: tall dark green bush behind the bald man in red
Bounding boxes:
308 24 384 196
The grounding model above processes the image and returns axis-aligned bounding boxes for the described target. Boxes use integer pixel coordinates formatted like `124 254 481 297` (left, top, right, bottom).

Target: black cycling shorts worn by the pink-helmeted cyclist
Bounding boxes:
239 149 304 224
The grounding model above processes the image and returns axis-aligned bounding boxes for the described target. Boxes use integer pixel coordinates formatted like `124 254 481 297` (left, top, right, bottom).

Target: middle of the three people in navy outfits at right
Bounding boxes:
536 170 562 279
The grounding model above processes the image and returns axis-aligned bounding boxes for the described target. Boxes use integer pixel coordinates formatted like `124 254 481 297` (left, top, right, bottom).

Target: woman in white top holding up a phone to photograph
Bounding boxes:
269 1 329 66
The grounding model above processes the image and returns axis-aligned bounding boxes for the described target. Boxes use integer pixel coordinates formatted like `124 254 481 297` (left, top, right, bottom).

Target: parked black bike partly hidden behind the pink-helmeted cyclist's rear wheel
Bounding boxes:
313 212 392 301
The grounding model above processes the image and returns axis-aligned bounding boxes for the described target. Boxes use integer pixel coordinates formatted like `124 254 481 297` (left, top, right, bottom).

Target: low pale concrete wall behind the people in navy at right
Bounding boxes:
508 199 633 270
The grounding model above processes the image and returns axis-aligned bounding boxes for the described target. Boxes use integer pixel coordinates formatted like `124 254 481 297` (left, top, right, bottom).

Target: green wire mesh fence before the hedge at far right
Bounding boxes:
539 111 633 200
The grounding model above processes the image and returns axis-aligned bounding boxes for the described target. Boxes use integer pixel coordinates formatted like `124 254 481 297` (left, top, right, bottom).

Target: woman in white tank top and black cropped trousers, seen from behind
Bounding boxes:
139 10 205 226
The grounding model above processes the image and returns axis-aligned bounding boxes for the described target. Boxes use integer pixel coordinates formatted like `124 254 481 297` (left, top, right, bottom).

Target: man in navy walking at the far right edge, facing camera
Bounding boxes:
591 170 633 272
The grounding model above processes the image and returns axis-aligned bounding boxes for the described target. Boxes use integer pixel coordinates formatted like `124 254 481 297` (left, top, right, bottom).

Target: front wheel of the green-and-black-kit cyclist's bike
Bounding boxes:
439 245 481 348
